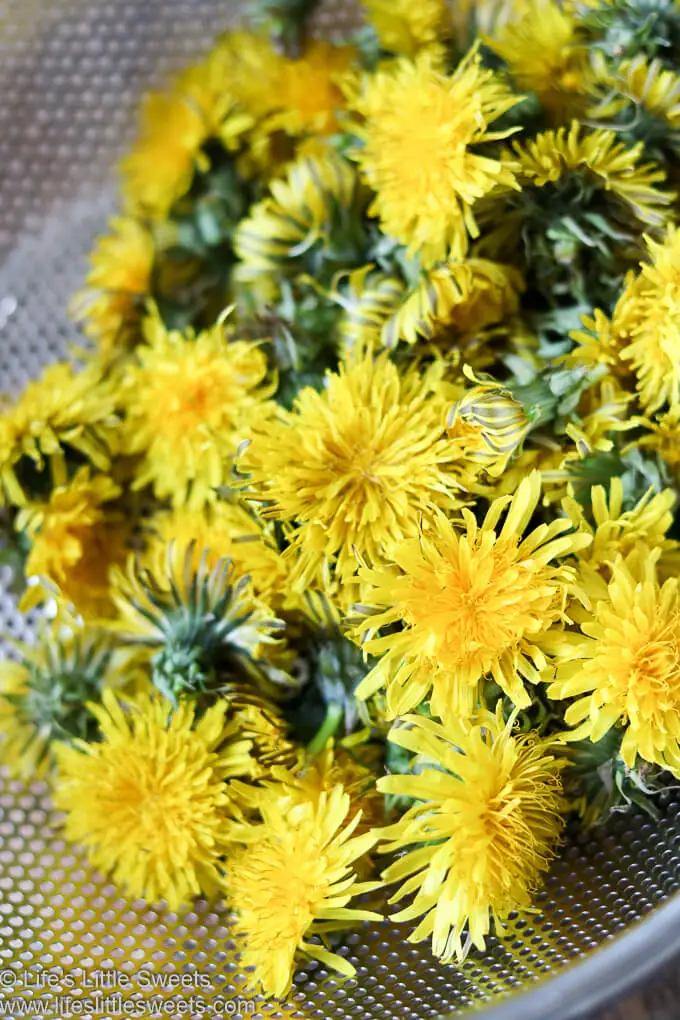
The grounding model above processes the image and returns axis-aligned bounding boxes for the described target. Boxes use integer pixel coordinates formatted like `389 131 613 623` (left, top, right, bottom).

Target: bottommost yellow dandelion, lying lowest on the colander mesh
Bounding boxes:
225 786 380 999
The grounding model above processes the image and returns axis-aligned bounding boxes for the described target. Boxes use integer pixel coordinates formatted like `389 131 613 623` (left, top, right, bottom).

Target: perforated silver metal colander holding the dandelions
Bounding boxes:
0 0 680 1020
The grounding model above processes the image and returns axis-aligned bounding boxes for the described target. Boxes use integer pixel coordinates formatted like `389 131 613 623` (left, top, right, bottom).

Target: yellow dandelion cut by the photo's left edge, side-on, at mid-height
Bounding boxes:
0 362 119 506
